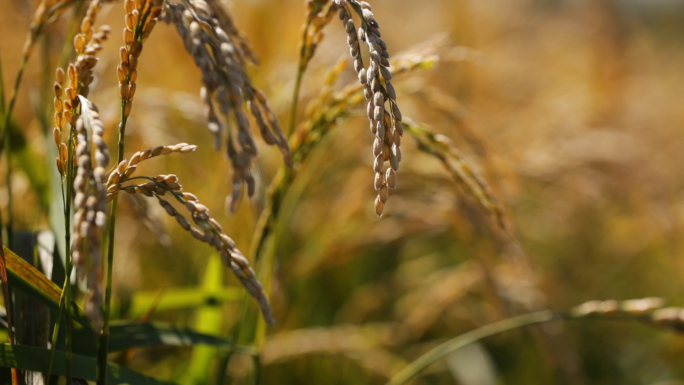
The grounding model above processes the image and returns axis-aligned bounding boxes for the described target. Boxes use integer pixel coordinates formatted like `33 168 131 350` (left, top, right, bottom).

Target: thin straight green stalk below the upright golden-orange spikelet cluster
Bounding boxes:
97 99 128 385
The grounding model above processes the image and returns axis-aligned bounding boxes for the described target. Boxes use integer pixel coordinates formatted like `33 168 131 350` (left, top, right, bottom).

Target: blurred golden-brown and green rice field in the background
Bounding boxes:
0 0 684 384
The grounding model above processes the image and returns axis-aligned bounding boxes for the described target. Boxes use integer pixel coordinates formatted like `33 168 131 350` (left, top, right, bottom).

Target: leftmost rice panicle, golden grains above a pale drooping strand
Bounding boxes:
48 0 110 327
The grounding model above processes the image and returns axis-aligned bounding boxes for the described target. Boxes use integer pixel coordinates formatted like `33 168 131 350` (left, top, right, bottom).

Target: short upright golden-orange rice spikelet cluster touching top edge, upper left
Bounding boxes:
116 0 162 120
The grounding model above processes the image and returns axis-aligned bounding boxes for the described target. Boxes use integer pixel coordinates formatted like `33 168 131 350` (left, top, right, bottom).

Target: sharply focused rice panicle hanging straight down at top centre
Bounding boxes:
336 0 404 217
